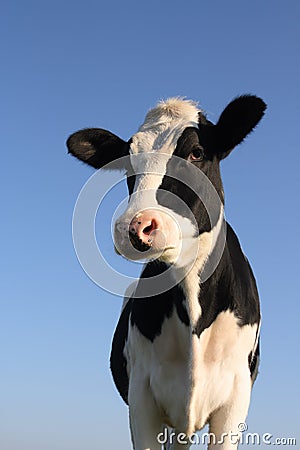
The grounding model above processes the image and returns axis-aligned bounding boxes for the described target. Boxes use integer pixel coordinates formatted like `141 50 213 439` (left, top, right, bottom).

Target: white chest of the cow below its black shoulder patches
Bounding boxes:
125 311 257 435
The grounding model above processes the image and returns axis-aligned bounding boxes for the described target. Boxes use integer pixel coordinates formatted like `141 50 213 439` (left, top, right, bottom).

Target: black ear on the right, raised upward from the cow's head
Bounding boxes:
210 95 267 159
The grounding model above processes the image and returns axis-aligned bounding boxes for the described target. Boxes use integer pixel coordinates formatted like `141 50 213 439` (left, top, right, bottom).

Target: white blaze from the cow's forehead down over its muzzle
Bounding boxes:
115 98 200 262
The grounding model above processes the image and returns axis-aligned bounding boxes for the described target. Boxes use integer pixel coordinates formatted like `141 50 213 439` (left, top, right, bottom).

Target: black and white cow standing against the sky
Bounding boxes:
67 94 266 450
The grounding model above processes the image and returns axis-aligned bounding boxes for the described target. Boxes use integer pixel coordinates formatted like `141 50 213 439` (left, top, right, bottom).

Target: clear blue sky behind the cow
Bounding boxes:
0 0 300 450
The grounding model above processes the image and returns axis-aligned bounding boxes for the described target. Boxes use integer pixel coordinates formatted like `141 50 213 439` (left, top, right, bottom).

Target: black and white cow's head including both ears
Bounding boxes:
67 95 266 265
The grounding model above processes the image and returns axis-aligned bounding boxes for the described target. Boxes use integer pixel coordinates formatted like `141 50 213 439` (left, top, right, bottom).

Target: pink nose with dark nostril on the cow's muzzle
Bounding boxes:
129 210 160 245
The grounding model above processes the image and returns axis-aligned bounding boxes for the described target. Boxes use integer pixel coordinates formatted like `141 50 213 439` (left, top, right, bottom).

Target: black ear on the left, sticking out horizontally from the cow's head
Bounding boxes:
67 128 129 170
